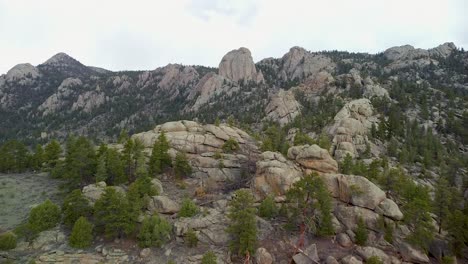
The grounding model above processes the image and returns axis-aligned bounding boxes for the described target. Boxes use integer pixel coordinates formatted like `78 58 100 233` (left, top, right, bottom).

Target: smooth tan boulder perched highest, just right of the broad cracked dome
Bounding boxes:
288 145 338 173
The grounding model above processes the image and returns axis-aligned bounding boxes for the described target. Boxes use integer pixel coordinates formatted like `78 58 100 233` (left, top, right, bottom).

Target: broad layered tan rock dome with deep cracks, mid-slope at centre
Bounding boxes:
132 120 258 183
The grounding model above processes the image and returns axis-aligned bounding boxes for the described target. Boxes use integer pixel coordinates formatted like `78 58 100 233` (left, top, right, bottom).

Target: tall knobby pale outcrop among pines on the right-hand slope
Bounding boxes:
326 99 377 160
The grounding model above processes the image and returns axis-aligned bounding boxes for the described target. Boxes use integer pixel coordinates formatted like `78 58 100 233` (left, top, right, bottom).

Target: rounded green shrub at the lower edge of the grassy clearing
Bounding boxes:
28 199 60 233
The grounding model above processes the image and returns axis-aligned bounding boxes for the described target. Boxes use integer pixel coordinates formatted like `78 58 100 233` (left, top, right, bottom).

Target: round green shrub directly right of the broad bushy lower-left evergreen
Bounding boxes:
138 215 172 248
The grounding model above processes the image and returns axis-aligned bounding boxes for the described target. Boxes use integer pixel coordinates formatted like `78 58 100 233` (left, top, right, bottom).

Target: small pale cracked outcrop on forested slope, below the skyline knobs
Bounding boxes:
265 89 301 126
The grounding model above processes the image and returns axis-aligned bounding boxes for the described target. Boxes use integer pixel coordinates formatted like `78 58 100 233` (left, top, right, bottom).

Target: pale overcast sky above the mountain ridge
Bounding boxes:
0 0 468 74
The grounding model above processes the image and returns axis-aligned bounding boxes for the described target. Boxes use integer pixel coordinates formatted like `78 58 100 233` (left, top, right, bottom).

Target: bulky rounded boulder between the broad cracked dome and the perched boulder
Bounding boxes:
252 151 302 198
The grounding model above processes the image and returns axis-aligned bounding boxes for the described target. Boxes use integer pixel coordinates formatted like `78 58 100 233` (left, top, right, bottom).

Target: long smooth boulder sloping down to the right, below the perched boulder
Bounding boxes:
321 174 386 209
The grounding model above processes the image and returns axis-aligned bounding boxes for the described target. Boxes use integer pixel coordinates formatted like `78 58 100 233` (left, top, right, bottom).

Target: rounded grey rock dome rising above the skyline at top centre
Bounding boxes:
219 48 263 83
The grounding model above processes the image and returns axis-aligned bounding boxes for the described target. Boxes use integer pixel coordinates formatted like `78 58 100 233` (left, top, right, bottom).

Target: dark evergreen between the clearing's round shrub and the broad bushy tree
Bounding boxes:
62 189 93 227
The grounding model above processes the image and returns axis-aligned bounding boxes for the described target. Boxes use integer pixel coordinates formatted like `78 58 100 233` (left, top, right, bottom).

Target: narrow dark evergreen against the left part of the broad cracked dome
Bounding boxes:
149 132 172 177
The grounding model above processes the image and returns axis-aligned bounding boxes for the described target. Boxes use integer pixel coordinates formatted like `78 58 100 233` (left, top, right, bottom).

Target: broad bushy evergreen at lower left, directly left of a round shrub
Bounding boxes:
94 187 135 238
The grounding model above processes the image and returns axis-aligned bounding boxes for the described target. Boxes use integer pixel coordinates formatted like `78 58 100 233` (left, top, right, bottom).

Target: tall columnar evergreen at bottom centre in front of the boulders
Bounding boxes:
227 190 257 256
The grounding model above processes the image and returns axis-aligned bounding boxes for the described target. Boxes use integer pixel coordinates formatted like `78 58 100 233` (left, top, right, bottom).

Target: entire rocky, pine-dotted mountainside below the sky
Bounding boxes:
0 43 468 264
